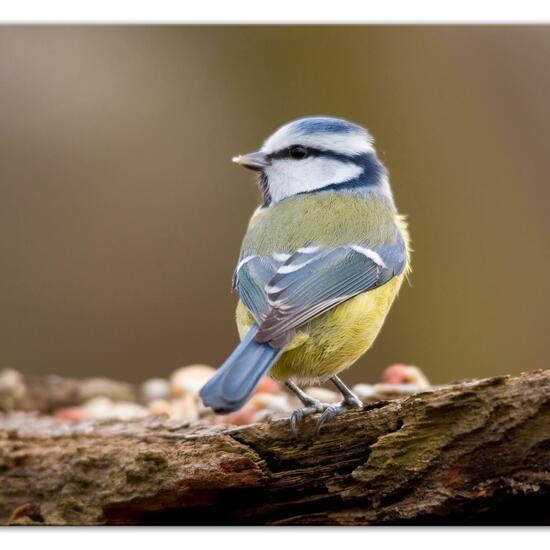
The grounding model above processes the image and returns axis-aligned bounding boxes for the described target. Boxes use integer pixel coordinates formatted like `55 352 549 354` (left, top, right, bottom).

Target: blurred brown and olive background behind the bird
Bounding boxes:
0 26 550 388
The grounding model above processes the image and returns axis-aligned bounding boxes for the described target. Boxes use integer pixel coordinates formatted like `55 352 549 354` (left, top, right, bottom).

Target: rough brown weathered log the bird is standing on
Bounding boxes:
0 371 550 525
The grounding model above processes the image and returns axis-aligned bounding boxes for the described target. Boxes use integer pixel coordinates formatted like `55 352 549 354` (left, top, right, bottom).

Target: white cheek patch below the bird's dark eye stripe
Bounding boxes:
265 157 363 202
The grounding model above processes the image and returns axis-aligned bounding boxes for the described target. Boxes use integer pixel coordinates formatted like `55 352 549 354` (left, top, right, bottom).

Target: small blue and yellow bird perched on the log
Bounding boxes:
200 117 410 435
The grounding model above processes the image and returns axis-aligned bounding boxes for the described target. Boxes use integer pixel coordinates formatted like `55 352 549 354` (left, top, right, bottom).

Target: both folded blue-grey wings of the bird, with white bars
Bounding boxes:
236 234 407 346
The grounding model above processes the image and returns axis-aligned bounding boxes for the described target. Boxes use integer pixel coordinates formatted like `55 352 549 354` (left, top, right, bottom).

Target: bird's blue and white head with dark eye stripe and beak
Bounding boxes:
233 117 392 206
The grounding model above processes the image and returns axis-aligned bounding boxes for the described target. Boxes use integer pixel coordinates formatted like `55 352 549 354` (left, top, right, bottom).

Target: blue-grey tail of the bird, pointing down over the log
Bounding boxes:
200 325 282 414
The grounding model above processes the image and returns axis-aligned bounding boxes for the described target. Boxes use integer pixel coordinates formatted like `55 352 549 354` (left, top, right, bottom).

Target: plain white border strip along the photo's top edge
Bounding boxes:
0 0 550 24
